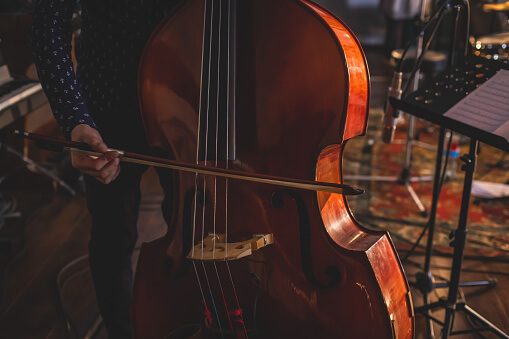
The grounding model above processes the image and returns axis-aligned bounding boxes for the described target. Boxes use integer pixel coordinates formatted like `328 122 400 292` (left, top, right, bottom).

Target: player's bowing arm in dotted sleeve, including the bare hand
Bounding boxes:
30 0 120 184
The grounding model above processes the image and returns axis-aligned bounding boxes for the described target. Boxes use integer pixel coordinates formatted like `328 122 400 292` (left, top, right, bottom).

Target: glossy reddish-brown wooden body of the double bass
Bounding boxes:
132 0 414 338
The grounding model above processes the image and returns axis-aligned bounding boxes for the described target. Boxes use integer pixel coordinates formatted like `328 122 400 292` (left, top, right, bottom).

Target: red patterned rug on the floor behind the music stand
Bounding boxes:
343 109 509 258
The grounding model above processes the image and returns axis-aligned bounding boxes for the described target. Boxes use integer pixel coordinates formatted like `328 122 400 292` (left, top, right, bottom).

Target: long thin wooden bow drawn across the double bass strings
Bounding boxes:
14 130 364 195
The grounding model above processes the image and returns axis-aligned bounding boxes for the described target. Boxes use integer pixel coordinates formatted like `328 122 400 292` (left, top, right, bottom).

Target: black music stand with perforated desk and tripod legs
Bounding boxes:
391 56 509 339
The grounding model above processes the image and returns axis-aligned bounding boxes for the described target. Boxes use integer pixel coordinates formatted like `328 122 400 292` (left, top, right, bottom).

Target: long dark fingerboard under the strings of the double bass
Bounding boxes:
198 0 236 161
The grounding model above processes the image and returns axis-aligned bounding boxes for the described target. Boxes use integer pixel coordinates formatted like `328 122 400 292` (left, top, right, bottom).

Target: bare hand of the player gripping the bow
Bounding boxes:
71 124 120 184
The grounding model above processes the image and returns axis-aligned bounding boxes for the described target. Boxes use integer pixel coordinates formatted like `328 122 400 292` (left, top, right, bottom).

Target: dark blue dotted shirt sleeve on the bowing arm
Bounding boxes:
30 0 96 139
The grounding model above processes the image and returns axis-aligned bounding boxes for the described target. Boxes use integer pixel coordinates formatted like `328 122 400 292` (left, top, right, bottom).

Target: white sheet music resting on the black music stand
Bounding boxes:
444 69 509 141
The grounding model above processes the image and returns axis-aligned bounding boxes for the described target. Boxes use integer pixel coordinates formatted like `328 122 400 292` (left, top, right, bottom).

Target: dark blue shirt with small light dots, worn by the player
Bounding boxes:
31 0 177 138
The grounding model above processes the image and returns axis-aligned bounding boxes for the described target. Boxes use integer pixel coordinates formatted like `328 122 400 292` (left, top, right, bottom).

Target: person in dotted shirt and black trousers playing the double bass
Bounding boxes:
31 0 177 338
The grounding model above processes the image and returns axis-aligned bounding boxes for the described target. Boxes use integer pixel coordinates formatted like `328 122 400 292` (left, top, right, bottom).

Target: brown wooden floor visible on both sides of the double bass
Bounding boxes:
0 161 509 338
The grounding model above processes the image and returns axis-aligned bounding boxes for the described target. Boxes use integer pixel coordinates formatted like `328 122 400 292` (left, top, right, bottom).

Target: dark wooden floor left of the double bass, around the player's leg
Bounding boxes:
0 165 165 338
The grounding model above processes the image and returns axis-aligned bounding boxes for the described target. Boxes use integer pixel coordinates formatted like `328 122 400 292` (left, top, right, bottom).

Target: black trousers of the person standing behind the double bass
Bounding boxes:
85 163 172 339
